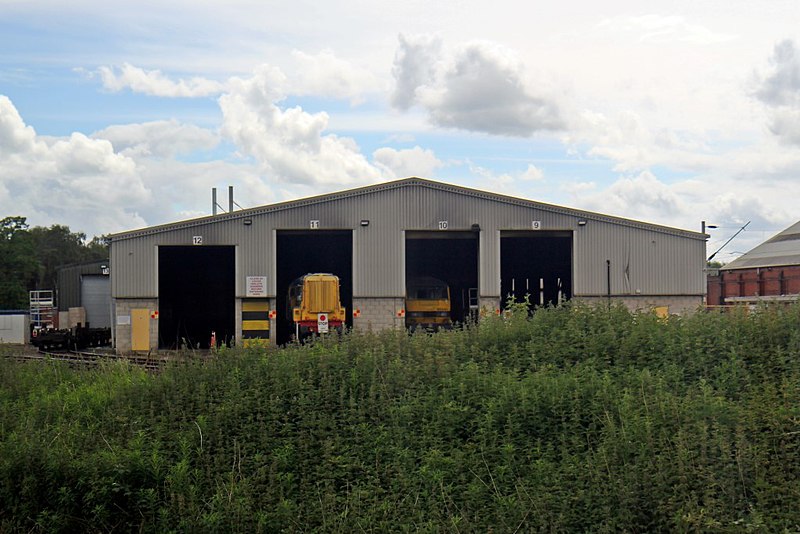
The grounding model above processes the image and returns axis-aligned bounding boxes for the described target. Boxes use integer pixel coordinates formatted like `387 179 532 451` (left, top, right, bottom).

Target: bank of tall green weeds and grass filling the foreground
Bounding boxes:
0 304 800 532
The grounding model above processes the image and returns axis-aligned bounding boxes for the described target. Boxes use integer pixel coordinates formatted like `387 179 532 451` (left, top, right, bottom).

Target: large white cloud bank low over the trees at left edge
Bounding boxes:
0 96 272 236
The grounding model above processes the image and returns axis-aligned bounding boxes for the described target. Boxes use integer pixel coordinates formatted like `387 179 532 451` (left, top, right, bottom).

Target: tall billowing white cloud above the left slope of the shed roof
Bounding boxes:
219 67 381 185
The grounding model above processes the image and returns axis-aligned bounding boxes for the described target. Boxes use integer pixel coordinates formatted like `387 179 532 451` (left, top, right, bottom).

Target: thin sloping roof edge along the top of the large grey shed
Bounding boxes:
110 177 706 240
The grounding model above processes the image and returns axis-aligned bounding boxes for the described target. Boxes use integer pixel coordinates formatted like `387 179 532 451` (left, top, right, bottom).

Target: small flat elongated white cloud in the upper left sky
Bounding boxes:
92 120 219 158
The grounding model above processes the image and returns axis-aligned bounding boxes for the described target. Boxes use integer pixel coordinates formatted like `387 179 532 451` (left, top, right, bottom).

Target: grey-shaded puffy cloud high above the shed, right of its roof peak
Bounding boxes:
392 35 564 137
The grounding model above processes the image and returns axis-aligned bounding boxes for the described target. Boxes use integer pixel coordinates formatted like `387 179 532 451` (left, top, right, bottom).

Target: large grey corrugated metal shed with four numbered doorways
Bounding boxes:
111 178 706 351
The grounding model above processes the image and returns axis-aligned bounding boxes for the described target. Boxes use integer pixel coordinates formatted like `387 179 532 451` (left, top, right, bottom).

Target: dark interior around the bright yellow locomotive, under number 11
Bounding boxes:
273 230 353 345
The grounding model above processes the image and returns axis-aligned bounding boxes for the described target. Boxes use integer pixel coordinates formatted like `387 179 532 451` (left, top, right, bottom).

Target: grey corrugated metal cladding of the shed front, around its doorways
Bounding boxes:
111 180 705 298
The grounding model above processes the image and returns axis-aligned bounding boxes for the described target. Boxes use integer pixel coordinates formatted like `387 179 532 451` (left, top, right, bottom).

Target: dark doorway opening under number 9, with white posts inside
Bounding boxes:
500 231 572 308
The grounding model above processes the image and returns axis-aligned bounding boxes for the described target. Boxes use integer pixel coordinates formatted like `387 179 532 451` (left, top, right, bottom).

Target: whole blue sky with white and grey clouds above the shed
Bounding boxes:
0 0 800 261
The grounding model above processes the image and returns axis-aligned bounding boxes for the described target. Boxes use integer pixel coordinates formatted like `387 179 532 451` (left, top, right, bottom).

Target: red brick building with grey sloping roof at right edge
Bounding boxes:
707 222 800 306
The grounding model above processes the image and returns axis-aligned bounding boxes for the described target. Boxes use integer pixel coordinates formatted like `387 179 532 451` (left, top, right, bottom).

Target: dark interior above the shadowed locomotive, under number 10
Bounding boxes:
406 232 478 323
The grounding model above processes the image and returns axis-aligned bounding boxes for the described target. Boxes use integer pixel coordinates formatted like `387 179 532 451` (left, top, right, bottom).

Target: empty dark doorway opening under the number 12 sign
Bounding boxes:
158 246 236 349
